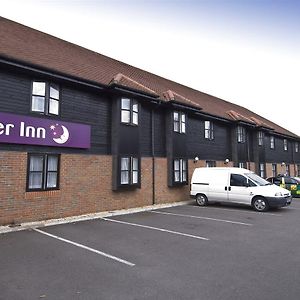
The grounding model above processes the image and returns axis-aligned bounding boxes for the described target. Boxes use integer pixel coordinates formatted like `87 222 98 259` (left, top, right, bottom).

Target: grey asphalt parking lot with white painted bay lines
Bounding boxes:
0 199 300 300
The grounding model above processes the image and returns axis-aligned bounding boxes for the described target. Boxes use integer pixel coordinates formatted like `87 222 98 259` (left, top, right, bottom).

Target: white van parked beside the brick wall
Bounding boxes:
190 168 292 211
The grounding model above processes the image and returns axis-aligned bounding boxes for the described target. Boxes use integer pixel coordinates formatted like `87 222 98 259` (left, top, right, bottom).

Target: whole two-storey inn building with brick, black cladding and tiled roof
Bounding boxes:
0 18 300 225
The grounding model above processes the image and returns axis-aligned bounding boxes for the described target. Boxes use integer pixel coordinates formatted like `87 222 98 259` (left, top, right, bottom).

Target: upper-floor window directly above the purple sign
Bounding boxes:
31 81 60 116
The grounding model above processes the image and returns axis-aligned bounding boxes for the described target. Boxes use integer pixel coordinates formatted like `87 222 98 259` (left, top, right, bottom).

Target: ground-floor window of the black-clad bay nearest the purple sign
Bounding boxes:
120 157 139 185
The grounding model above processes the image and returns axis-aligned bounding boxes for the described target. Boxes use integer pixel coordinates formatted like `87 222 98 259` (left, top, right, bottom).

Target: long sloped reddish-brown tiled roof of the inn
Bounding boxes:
0 17 298 137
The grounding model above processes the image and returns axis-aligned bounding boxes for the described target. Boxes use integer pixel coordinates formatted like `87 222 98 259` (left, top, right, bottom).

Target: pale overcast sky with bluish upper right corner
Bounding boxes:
0 0 300 135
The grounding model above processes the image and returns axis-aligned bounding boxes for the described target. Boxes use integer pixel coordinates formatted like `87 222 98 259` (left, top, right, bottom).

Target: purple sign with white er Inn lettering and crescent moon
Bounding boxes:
0 112 91 148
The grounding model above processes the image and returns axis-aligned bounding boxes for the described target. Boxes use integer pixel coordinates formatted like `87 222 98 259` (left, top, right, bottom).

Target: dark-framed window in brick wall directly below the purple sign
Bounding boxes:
27 154 60 191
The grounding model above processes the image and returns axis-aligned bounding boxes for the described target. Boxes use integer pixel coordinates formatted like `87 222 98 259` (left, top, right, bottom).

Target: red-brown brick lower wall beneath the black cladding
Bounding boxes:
0 151 290 225
